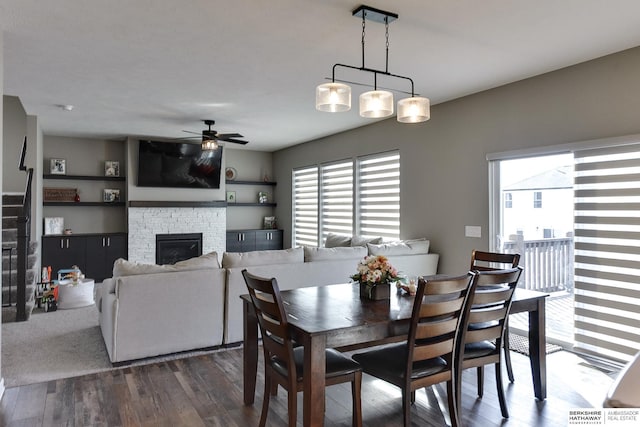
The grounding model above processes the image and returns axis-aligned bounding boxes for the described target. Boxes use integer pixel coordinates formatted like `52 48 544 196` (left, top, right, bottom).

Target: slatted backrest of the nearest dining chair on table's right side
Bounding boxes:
406 272 476 370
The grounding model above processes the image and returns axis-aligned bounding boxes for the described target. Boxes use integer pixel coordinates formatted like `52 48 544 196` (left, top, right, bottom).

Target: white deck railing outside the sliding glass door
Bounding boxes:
502 237 573 292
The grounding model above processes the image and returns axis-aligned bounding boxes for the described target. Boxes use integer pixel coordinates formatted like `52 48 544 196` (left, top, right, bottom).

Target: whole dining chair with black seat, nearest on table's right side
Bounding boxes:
352 272 477 427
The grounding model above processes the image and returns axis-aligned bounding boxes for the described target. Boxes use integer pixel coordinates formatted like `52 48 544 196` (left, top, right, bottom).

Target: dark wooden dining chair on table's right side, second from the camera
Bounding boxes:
457 267 523 418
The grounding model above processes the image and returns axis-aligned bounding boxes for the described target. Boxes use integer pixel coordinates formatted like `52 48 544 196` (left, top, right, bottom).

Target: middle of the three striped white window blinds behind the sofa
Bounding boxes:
320 160 353 242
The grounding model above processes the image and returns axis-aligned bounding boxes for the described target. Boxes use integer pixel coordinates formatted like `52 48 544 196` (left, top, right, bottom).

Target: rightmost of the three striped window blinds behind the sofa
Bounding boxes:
357 152 400 240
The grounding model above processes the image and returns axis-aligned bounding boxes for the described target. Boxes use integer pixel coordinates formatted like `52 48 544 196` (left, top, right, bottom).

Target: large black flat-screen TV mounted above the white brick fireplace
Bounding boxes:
138 140 222 188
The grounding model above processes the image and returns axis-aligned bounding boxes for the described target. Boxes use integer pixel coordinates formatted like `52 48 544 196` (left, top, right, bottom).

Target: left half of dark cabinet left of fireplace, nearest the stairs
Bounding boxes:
42 236 86 279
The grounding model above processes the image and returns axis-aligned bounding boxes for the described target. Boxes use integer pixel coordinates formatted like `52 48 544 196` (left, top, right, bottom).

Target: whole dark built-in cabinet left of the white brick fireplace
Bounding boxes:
42 233 127 281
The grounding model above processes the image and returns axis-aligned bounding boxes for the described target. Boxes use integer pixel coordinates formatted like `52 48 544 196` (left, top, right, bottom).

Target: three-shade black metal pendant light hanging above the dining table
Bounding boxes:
316 6 431 123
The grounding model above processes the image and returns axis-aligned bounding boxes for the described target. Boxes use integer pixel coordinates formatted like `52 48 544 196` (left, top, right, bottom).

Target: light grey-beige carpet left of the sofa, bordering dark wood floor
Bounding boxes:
1 306 231 387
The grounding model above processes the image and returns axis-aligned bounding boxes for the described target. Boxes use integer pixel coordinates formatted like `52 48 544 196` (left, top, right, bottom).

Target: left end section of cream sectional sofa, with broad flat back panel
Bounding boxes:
96 252 225 363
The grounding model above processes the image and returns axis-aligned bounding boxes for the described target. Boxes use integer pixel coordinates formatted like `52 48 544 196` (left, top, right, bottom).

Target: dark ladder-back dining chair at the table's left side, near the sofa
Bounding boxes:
242 269 362 427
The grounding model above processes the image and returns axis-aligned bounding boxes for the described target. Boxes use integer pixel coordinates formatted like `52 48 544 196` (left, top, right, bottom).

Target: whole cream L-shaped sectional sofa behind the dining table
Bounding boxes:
96 239 439 364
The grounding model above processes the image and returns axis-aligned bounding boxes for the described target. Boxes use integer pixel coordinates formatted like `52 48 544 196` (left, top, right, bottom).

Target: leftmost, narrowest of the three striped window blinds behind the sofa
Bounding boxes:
293 166 318 247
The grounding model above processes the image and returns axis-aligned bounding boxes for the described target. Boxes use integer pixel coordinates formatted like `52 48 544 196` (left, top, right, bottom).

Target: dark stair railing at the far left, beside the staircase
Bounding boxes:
16 136 33 322
